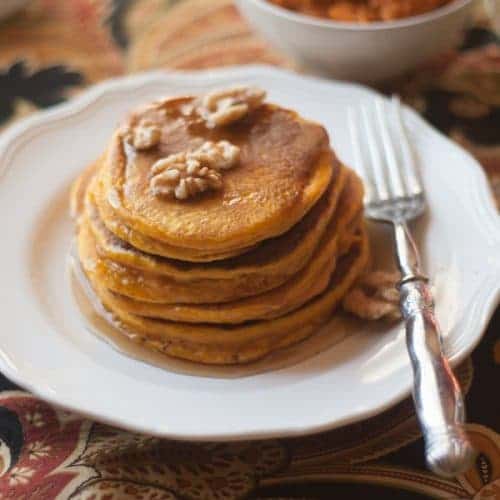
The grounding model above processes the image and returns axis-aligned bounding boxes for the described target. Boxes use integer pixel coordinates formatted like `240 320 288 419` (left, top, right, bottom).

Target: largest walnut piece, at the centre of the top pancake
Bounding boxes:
150 141 240 200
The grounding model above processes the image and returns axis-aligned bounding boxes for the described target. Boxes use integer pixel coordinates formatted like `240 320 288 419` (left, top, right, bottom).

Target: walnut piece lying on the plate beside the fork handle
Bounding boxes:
342 271 401 321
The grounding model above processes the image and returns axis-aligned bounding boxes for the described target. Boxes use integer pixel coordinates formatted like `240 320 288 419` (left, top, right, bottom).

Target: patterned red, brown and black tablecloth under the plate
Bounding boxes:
0 0 500 500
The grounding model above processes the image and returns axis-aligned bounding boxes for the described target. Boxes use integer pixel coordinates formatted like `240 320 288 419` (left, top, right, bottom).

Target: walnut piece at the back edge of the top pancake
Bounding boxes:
197 86 266 128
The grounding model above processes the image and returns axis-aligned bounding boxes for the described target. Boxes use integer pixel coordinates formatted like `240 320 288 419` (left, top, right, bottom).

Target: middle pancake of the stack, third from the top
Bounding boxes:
79 172 362 304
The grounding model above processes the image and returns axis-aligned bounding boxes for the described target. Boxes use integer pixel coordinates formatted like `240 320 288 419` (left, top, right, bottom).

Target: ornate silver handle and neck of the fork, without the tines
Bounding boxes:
393 221 474 477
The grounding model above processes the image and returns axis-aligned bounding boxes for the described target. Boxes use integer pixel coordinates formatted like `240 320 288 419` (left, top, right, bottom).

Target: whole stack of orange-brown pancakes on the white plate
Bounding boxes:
72 88 368 364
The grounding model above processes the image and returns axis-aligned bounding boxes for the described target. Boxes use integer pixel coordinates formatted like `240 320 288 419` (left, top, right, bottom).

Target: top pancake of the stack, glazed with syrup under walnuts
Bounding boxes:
99 94 333 257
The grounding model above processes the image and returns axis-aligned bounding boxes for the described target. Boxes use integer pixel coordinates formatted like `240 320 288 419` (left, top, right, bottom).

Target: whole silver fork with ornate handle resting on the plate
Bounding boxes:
348 97 474 477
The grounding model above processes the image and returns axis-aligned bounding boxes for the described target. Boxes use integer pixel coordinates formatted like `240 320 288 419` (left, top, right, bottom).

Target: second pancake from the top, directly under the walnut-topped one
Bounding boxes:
86 162 352 290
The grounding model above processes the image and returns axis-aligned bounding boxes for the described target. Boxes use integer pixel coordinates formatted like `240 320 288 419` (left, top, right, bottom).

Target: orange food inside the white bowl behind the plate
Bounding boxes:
269 0 451 22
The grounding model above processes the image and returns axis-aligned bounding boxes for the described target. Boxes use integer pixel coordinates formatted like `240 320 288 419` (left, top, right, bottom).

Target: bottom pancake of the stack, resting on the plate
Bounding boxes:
82 230 369 364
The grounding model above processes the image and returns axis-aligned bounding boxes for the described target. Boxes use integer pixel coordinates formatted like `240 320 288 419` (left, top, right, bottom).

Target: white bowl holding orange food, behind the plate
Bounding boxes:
236 0 473 83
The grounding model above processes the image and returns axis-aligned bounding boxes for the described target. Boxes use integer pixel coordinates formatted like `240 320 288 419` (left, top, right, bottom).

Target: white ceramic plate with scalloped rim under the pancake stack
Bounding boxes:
0 67 500 440
